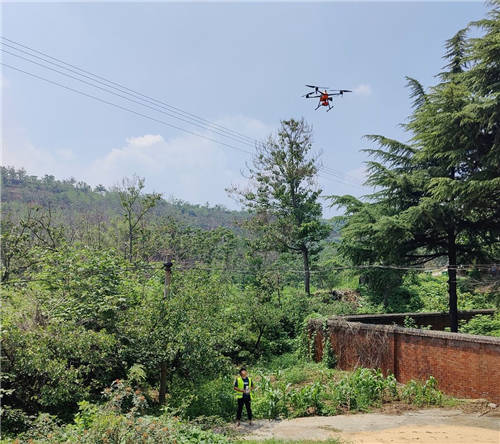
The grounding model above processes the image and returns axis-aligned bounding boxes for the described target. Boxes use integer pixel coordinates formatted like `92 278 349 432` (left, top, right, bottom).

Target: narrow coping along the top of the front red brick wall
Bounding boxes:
309 317 500 347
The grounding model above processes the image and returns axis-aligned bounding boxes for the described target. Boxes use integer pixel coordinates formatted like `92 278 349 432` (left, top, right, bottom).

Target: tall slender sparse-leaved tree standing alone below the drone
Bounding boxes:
230 119 330 295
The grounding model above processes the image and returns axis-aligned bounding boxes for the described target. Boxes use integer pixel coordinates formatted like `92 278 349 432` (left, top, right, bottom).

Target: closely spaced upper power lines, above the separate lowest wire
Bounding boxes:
0 36 257 143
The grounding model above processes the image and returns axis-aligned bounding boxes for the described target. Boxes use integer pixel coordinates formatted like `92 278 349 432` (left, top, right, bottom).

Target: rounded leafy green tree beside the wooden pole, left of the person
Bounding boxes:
124 268 234 402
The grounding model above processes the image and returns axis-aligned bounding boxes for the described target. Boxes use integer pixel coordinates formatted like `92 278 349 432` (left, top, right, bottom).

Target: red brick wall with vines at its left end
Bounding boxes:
310 319 500 403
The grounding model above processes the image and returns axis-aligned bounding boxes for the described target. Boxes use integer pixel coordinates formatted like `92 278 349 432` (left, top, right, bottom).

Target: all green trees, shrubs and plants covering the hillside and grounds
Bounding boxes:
0 2 500 443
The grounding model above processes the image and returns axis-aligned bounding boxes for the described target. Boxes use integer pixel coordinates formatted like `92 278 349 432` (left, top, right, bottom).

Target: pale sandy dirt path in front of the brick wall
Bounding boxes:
242 409 500 444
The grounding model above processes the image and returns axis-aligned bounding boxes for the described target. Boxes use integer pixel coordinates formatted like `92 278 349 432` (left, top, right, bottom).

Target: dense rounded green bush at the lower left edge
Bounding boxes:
2 321 120 419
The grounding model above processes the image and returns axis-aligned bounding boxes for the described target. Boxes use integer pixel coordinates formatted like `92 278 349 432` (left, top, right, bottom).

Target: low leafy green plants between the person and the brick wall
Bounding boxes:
250 364 443 419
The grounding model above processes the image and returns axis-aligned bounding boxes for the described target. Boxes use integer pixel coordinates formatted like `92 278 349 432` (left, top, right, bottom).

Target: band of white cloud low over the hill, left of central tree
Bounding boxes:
2 116 272 208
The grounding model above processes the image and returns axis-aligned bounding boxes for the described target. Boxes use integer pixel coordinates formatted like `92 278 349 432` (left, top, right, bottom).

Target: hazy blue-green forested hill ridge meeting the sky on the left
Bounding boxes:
1 166 246 229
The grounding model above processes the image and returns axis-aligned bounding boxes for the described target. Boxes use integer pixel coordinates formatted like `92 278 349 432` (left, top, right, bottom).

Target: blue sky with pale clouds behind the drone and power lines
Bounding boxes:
1 2 487 215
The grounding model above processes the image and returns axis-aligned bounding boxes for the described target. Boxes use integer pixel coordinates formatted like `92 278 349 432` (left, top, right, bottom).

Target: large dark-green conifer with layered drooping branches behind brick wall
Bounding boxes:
333 14 500 331
